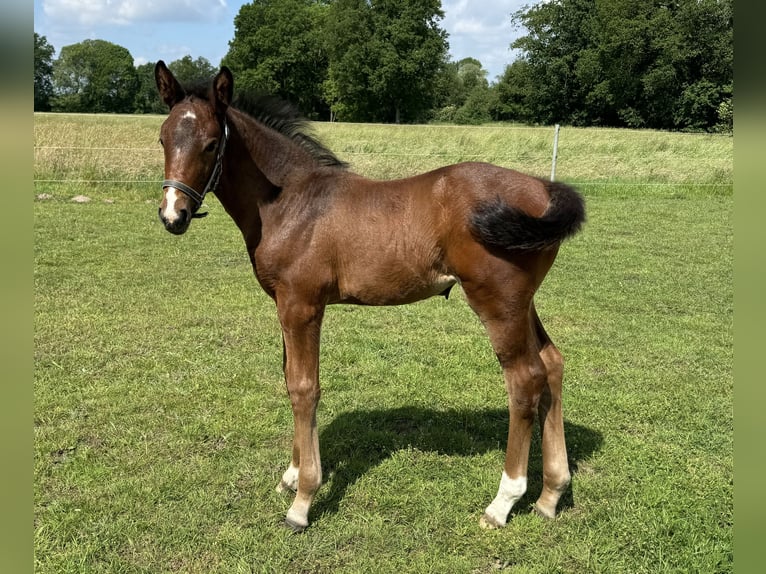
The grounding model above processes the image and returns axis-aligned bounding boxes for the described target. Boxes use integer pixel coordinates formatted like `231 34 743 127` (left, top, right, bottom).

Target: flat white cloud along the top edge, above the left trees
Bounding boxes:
42 0 226 27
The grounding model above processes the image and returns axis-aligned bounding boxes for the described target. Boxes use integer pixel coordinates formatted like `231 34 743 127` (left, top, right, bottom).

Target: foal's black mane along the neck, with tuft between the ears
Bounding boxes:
184 81 348 169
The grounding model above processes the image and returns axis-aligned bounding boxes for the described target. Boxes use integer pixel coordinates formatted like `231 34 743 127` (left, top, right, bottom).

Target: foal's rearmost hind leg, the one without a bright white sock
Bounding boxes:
532 307 571 518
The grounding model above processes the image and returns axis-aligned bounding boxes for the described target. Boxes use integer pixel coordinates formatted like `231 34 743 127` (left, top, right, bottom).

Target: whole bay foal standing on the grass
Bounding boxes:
155 61 585 531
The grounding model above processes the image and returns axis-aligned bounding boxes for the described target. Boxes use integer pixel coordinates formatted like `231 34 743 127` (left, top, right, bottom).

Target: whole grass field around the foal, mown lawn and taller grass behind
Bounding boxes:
34 115 734 574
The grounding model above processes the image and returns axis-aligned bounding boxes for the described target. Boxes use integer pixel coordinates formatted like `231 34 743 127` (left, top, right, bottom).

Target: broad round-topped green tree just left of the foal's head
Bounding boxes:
52 40 138 113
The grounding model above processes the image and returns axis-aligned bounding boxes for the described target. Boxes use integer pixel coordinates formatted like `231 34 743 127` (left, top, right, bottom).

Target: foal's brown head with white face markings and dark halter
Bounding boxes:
154 60 234 235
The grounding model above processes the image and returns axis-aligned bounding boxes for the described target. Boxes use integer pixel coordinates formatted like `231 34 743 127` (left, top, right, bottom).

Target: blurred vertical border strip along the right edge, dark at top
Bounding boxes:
734 2 766 572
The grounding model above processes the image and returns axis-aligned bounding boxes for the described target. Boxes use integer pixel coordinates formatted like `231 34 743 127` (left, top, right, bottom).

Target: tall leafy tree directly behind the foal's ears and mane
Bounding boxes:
222 0 329 117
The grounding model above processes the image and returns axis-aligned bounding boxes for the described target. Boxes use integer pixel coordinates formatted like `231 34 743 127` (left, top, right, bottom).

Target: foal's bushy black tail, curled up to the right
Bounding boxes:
471 182 585 250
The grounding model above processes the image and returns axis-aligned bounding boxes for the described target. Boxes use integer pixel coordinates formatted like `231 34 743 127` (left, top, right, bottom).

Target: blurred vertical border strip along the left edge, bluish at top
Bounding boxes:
0 0 34 572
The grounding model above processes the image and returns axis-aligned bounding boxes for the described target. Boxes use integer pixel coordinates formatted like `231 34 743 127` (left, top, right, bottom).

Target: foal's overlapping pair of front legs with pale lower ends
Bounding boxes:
277 297 324 532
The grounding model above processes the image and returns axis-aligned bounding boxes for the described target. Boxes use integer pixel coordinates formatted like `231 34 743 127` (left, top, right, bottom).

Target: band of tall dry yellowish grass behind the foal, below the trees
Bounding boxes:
34 114 734 201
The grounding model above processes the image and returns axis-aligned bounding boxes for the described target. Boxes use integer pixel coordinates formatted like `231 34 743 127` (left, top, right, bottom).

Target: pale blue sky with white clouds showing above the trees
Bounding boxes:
34 0 534 81
